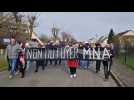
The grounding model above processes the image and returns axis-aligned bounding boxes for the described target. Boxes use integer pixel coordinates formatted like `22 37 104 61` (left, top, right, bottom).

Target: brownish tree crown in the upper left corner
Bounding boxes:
0 12 28 41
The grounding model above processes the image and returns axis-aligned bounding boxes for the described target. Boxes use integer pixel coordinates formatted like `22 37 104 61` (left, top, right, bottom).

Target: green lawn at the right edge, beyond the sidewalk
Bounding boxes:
117 54 134 70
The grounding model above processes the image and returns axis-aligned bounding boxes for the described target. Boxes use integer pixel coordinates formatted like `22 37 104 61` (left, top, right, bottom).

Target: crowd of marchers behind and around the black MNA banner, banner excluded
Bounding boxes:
6 37 114 79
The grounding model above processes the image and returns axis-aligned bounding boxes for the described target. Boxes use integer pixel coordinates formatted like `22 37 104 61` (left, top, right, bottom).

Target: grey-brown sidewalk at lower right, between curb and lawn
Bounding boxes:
112 61 134 87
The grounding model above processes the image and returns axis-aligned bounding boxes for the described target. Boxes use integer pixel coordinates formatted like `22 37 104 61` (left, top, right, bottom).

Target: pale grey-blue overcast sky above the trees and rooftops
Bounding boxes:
35 12 134 41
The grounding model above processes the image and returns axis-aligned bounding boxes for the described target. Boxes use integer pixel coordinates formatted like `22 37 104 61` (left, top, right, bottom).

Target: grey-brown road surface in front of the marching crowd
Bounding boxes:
0 62 117 87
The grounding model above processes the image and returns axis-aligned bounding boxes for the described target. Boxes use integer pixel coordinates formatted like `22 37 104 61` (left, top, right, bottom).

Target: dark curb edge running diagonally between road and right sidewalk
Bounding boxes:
110 71 127 87
